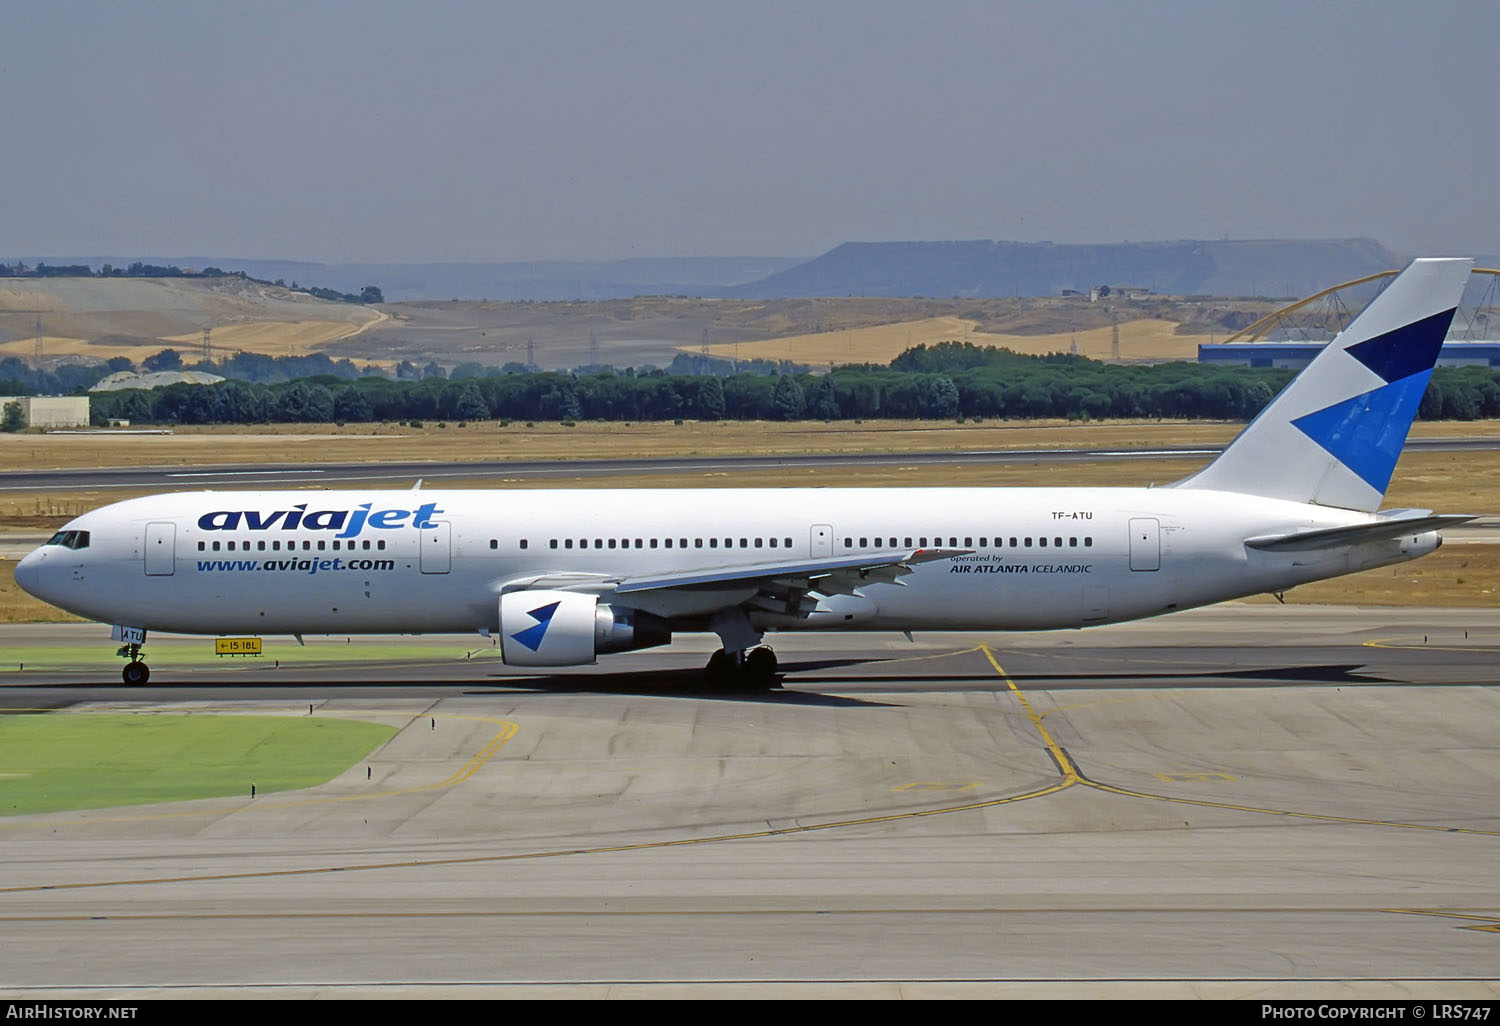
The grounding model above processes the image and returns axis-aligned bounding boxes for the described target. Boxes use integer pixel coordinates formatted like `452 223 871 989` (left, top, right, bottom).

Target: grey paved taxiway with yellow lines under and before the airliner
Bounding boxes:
0 606 1500 999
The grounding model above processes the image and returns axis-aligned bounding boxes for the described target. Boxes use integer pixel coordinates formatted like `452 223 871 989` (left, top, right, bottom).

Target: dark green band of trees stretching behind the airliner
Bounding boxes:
82 354 1500 425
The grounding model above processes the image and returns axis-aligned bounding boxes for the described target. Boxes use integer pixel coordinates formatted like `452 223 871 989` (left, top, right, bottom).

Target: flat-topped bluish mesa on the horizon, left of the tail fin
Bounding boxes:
717 239 1406 299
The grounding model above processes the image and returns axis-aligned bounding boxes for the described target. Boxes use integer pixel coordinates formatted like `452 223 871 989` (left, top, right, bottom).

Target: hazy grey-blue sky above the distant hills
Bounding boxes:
0 0 1500 261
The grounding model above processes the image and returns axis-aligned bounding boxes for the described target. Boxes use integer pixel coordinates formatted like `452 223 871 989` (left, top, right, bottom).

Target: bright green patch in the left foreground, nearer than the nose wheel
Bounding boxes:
0 713 396 816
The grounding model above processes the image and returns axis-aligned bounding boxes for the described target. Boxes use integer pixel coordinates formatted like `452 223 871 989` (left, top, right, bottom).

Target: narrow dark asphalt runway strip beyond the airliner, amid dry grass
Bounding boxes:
0 438 1500 492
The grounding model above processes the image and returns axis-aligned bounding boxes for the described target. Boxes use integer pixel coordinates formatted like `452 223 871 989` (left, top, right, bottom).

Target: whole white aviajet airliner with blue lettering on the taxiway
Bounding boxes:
15 260 1472 684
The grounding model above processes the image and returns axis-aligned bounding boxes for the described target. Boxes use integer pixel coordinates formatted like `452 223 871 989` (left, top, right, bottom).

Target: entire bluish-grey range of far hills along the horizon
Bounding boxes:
11 239 1440 303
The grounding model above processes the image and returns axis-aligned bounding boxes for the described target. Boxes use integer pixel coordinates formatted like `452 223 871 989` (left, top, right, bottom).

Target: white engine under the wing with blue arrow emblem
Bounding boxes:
500 591 672 666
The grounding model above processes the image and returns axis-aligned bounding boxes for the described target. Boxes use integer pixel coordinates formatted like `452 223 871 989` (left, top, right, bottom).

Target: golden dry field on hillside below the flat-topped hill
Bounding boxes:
696 317 1212 366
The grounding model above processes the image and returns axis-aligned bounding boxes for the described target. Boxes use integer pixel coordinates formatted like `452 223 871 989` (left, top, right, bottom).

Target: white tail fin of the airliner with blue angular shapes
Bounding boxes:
1173 258 1473 513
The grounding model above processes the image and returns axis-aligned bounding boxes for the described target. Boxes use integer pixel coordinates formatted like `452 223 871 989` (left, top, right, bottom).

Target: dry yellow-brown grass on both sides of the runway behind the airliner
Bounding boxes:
0 422 1500 623
